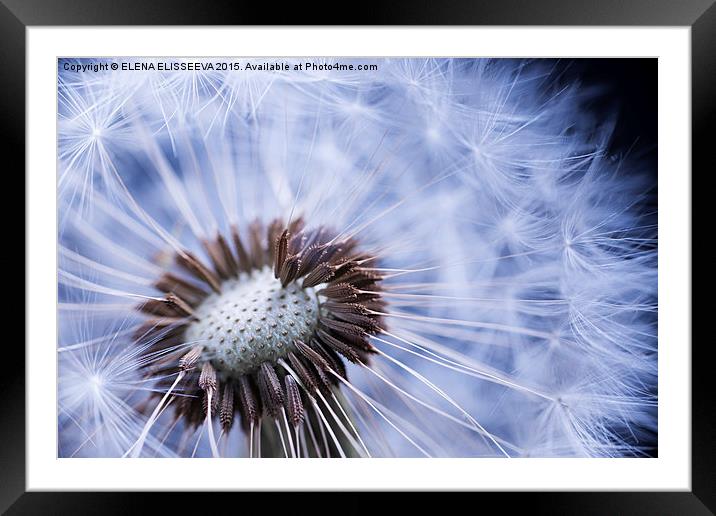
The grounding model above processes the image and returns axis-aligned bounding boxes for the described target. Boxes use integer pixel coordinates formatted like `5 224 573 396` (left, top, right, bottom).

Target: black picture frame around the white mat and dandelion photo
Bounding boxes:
0 0 716 514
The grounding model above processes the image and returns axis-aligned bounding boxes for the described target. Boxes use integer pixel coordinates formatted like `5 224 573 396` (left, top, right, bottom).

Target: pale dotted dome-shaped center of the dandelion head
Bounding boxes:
186 267 320 376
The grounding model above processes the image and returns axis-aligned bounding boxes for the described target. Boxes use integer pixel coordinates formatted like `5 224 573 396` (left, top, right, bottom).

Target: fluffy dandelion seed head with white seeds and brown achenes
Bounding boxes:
58 59 657 458
